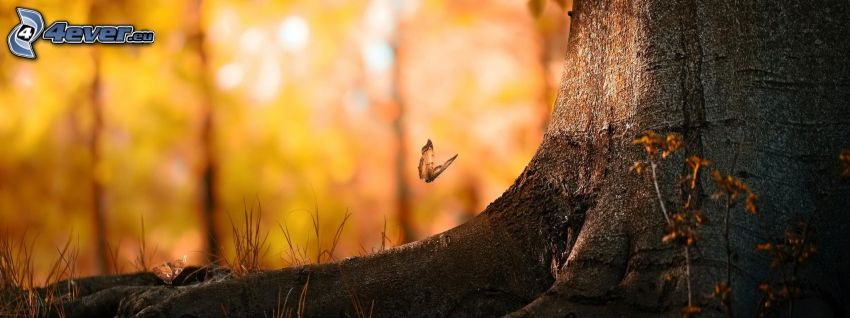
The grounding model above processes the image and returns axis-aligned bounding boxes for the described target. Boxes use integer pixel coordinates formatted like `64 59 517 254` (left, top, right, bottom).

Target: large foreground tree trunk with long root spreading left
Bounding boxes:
49 0 850 317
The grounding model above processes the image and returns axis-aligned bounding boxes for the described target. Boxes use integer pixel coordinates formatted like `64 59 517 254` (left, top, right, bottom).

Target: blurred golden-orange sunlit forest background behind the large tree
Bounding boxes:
0 0 569 275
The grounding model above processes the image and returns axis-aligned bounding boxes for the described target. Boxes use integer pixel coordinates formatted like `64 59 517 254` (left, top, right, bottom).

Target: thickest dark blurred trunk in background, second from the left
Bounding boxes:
188 0 220 262
